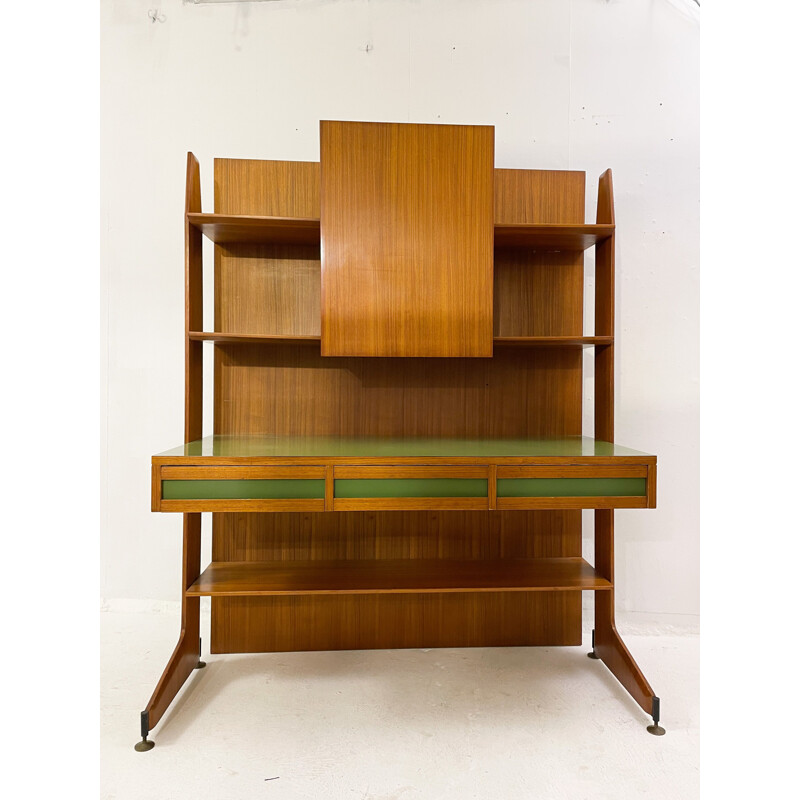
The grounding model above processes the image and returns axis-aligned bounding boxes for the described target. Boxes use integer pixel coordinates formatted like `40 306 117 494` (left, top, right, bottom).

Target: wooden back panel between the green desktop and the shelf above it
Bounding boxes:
214 344 582 439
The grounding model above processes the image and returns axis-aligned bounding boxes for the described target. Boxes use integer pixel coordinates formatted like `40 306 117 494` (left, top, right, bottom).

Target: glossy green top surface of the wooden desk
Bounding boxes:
153 436 647 458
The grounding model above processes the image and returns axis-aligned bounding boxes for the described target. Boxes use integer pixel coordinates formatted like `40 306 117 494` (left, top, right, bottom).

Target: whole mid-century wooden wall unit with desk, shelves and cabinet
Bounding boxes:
137 122 663 749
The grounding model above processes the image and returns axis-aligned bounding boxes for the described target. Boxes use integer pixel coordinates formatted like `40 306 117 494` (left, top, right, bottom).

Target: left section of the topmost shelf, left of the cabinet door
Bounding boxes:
186 213 319 246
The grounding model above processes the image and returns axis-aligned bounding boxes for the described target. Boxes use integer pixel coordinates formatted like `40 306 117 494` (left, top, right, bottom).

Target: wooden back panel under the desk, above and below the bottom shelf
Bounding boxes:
206 511 581 653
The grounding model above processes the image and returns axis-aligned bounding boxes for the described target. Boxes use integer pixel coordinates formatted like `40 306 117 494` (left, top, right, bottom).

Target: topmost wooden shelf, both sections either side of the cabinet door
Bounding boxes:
186 213 614 250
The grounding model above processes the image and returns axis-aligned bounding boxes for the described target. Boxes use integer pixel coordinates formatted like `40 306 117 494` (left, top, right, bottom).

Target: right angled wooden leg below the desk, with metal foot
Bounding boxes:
592 509 664 736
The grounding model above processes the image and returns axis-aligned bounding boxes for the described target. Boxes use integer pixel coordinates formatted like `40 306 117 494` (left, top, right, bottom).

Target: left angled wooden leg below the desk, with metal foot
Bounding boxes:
136 514 205 752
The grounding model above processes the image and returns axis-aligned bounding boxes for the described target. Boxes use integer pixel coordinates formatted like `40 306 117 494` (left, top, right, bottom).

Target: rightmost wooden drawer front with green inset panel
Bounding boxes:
497 465 655 509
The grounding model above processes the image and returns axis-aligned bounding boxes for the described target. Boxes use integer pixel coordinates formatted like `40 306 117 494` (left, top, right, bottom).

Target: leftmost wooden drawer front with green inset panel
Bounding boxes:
153 467 325 511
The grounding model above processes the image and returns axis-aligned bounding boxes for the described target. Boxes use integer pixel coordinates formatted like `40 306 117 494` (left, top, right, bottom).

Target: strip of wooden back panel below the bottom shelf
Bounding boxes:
211 592 580 653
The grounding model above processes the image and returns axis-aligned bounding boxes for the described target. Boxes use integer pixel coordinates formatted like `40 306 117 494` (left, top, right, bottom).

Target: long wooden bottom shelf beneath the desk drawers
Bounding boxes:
186 558 611 597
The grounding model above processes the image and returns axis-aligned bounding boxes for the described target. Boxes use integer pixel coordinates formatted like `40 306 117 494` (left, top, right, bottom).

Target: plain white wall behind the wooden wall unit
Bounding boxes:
101 0 699 622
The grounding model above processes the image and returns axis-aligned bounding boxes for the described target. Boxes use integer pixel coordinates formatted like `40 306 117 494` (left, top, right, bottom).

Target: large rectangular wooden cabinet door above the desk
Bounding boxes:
320 121 494 357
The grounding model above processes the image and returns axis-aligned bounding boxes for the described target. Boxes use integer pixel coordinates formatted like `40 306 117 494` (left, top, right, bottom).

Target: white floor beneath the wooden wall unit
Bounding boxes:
101 612 699 800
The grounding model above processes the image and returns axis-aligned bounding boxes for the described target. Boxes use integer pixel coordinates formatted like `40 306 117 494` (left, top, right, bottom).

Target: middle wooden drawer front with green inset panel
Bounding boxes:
333 467 489 511
